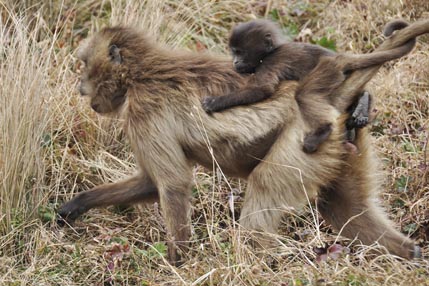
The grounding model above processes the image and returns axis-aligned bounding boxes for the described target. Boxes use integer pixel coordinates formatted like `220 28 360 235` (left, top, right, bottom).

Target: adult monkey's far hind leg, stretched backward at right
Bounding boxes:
318 129 421 259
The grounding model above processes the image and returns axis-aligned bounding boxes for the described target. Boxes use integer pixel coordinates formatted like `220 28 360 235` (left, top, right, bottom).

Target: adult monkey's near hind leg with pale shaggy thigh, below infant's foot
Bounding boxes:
240 123 343 255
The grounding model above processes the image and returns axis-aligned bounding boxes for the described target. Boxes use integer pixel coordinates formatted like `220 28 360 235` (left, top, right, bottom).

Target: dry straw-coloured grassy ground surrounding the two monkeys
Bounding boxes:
0 0 429 285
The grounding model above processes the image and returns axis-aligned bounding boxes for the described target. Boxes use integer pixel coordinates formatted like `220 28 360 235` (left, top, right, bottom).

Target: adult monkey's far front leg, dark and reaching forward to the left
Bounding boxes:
57 174 158 225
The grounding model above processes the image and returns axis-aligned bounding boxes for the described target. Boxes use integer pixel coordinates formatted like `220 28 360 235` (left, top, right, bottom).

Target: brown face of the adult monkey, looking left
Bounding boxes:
78 38 127 113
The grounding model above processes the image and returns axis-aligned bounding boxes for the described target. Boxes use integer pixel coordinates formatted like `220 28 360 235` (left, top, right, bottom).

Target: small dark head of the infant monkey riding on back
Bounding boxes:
229 20 282 73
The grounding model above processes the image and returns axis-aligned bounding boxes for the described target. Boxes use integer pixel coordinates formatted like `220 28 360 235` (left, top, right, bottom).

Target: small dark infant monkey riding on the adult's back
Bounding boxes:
202 20 408 153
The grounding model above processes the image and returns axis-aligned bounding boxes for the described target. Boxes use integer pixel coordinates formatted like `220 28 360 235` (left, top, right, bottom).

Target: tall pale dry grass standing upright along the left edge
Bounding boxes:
0 7 62 235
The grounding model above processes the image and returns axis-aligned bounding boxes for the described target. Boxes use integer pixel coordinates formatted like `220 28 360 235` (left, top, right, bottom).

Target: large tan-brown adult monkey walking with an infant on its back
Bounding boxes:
59 18 429 261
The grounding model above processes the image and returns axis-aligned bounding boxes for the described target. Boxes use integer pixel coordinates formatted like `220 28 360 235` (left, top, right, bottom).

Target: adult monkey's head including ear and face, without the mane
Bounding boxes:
77 27 144 113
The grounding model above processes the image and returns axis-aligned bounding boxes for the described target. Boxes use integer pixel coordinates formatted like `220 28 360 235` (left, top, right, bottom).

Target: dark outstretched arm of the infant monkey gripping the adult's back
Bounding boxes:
201 66 282 113
